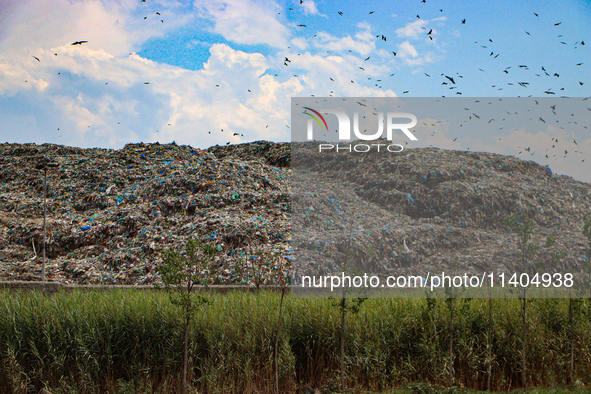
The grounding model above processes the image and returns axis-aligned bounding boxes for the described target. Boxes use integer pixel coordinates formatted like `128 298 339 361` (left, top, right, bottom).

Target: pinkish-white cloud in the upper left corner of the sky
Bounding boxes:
0 0 195 94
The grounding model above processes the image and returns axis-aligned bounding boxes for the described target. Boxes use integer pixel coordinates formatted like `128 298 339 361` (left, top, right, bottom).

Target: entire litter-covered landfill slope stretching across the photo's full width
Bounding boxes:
0 141 591 284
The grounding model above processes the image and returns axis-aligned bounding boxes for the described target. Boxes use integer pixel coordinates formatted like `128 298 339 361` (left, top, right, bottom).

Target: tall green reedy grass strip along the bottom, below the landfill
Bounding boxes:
0 290 591 394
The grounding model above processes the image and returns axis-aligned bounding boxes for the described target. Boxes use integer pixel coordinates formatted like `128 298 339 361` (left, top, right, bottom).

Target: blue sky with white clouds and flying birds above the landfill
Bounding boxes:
0 0 591 182
